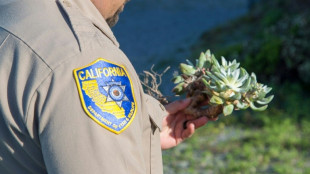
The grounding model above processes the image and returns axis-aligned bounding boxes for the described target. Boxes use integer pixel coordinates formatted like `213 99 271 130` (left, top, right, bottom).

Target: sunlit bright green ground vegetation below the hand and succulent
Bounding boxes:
164 118 310 174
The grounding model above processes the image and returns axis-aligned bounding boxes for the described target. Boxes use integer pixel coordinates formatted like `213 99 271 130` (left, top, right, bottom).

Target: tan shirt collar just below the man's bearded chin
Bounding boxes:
72 0 119 47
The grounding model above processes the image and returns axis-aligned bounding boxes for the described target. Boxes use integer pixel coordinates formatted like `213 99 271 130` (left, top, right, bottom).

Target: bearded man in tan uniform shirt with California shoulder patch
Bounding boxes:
0 0 208 174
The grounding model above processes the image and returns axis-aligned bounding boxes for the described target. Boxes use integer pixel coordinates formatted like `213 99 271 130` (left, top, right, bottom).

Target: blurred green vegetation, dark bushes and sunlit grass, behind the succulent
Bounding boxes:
163 0 310 174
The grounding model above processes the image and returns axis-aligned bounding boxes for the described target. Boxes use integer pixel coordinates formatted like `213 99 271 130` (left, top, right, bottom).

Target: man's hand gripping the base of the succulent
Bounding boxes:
160 98 212 149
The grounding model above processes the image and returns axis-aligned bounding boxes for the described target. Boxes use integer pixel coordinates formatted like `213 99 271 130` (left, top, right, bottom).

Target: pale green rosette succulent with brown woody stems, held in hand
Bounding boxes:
173 50 273 118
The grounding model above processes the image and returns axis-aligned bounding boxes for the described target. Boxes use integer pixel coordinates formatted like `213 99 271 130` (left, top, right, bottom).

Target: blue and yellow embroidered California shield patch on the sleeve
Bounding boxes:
73 58 137 134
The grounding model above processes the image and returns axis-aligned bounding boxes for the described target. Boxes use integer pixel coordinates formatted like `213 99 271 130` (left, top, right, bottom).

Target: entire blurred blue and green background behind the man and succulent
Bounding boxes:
113 0 310 174
